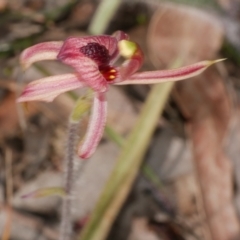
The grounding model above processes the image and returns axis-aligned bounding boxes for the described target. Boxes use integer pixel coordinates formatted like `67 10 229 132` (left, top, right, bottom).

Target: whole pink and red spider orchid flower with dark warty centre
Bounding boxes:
17 31 222 159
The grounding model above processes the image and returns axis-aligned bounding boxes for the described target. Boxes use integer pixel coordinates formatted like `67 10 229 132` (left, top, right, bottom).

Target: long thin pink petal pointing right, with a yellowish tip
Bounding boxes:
116 59 224 85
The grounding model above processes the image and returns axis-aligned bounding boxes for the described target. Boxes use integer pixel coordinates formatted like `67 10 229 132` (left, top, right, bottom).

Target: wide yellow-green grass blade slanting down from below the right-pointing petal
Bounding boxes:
81 82 173 240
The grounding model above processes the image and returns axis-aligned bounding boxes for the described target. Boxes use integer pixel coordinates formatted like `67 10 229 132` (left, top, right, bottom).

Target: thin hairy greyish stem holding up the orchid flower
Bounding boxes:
59 122 78 240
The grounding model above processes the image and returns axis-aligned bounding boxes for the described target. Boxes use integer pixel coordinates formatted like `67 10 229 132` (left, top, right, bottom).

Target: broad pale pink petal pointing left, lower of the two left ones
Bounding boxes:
17 73 85 102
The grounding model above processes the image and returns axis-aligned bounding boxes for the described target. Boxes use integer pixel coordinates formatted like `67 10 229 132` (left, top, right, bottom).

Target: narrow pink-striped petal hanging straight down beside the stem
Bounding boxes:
78 93 107 159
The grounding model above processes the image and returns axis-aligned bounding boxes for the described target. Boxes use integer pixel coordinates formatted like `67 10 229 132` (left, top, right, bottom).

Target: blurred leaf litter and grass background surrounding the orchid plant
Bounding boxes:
0 0 240 240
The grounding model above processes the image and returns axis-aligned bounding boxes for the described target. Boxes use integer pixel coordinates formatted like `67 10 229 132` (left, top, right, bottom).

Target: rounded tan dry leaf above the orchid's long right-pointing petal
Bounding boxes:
148 4 223 68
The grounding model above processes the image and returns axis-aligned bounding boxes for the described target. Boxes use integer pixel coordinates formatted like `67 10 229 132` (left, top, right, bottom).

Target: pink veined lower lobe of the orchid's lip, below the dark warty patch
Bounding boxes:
57 57 108 92
